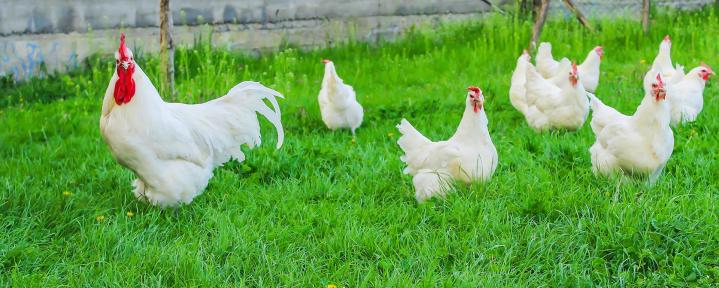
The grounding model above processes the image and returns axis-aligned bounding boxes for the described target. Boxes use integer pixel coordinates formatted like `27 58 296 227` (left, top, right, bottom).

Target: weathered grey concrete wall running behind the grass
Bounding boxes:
0 0 714 79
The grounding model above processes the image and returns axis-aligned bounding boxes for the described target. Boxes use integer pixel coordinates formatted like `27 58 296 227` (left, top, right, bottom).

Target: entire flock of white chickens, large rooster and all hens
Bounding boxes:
100 34 714 207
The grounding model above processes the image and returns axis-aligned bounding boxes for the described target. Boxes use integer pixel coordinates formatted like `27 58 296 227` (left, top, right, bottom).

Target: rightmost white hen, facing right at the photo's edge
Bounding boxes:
667 63 714 125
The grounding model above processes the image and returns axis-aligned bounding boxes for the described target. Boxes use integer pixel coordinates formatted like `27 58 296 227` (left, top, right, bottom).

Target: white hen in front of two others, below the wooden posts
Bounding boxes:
512 58 589 131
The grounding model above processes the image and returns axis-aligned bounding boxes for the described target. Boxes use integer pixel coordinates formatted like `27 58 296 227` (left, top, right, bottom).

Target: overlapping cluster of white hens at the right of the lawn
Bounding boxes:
509 36 714 187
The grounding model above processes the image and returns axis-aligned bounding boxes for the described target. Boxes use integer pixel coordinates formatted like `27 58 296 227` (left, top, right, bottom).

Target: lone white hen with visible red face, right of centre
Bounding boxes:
397 87 498 203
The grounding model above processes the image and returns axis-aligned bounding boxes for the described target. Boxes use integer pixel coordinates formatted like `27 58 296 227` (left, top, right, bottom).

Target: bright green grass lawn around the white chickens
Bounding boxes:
0 10 719 287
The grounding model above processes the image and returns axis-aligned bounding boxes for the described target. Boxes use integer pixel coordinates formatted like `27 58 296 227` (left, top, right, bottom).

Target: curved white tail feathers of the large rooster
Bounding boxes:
227 81 285 149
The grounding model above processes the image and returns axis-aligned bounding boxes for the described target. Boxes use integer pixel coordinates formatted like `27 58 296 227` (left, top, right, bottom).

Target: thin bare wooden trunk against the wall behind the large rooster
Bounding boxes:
160 0 177 101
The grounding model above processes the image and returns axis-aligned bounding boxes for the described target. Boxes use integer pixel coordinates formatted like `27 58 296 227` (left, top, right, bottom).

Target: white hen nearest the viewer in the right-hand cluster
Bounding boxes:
589 70 674 184
